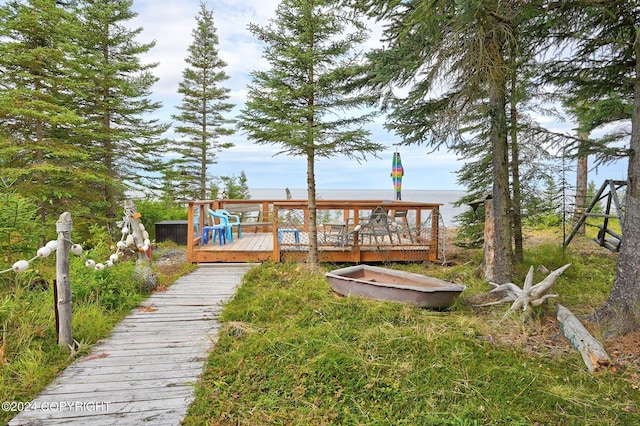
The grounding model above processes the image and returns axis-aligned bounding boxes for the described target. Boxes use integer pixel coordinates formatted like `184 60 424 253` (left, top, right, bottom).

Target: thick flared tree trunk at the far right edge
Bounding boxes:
593 28 640 336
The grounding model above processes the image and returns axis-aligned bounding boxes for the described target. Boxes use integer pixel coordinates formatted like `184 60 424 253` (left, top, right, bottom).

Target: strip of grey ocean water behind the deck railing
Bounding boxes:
249 188 469 226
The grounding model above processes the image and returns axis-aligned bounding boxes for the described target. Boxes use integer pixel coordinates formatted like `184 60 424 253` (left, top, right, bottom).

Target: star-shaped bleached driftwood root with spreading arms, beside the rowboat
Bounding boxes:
477 263 571 312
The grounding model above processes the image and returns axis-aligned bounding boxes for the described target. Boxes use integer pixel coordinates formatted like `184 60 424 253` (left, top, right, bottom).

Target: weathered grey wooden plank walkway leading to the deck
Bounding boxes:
9 263 252 426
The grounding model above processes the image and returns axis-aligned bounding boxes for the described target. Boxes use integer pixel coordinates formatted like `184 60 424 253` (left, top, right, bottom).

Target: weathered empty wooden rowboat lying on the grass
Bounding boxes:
325 265 467 308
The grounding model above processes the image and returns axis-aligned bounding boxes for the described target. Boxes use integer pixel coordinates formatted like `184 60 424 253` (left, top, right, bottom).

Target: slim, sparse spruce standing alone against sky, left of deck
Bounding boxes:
172 3 234 199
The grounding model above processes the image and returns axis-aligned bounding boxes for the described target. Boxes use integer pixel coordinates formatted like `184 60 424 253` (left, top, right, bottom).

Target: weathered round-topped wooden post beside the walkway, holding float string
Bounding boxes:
56 212 74 350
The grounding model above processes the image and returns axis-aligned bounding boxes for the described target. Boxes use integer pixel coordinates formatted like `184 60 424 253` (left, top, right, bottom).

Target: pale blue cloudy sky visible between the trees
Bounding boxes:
129 0 626 190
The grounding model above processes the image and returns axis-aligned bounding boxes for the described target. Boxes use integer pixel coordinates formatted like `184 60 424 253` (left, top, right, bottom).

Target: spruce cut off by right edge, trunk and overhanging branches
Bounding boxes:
545 0 640 334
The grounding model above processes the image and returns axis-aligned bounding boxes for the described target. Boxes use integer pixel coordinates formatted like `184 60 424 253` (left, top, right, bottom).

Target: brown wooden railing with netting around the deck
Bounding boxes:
188 199 441 262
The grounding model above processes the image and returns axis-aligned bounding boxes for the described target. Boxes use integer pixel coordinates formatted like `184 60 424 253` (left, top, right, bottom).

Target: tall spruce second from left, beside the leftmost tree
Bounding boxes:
75 0 168 223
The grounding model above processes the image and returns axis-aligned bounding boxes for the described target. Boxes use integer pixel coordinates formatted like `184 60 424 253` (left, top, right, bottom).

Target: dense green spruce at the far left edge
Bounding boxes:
0 0 100 233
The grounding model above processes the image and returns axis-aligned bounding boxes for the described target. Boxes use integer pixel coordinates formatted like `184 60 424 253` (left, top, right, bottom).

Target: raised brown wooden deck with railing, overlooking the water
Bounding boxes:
187 200 441 263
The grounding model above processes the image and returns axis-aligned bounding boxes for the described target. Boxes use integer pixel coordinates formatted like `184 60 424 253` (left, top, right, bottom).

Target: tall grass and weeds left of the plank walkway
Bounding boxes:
0 241 193 424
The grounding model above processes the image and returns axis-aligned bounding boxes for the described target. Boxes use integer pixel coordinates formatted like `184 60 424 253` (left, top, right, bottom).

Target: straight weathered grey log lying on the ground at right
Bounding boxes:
556 305 611 372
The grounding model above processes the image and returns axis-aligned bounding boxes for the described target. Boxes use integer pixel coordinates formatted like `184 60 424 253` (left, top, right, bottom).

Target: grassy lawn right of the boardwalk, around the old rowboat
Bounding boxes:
184 235 640 425
